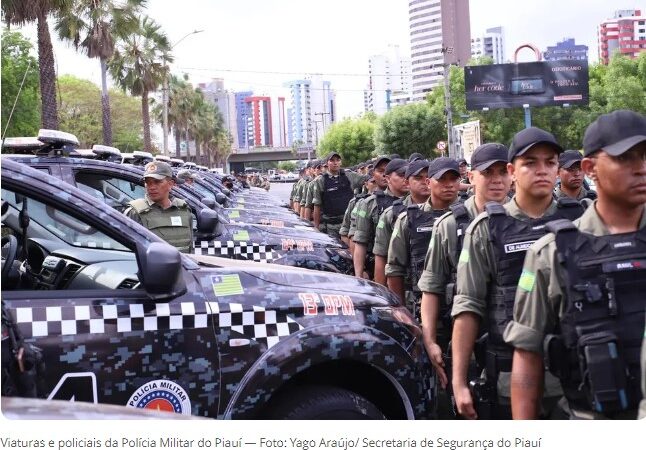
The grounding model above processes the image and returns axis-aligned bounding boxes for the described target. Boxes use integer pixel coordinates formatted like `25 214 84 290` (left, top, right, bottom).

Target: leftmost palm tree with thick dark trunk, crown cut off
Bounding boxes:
2 0 70 129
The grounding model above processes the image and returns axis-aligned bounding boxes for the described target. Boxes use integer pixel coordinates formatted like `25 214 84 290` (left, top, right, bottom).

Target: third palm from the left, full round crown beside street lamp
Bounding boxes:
108 16 173 151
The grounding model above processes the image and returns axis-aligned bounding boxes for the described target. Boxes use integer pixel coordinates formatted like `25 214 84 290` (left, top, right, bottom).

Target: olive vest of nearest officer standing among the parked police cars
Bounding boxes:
130 198 192 253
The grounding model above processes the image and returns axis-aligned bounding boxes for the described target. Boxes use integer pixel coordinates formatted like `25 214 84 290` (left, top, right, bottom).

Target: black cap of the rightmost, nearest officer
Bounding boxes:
583 109 646 156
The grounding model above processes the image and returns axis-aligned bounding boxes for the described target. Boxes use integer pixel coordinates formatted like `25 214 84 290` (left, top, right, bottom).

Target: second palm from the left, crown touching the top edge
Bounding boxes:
56 0 146 145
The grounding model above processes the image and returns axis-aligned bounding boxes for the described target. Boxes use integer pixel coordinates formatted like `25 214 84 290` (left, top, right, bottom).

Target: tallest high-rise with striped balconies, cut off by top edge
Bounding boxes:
408 0 471 101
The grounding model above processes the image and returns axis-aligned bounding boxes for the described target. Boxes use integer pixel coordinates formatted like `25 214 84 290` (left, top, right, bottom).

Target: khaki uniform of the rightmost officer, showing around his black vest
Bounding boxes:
504 206 646 418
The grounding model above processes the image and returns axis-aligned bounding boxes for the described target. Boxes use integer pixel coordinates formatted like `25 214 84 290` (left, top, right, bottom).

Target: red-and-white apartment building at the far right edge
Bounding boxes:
598 9 646 64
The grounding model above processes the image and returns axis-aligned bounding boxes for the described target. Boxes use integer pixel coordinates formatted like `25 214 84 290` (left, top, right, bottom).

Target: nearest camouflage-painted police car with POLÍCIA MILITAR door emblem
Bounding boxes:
1 159 434 419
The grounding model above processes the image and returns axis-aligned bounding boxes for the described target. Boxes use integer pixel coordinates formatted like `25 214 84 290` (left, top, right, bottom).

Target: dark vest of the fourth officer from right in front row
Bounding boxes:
406 205 446 291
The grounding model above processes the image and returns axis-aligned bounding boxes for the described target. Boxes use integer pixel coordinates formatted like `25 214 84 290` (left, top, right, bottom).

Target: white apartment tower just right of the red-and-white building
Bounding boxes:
285 76 336 146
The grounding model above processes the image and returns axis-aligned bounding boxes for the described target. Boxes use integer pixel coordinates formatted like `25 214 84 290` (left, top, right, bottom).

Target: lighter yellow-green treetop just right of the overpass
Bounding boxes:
317 118 375 166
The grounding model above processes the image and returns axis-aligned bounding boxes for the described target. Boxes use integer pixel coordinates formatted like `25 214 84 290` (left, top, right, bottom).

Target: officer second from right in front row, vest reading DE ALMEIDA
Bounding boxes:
451 127 583 418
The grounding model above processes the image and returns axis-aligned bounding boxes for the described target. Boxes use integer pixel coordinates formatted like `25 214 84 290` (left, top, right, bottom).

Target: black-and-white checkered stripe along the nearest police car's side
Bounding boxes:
15 302 302 347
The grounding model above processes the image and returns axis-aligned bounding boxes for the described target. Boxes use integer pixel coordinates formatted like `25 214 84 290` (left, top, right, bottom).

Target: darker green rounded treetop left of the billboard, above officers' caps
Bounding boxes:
375 103 446 158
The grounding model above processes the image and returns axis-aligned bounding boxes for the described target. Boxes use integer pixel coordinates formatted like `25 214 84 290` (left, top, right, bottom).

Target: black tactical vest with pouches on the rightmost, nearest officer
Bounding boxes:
545 220 646 416
